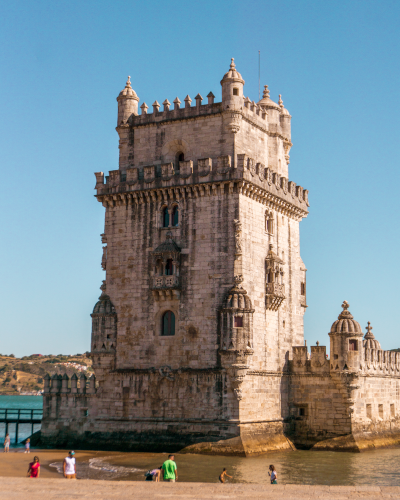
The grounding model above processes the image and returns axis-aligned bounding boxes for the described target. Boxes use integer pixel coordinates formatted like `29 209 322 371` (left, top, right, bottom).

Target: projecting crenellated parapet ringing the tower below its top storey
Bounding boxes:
95 154 309 217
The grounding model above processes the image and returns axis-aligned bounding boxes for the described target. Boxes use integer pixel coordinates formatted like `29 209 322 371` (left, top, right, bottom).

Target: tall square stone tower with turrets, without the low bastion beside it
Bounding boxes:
40 59 308 454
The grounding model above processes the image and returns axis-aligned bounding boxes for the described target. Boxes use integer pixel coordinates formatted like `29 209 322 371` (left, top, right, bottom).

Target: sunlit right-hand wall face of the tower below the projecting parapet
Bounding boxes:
235 196 305 370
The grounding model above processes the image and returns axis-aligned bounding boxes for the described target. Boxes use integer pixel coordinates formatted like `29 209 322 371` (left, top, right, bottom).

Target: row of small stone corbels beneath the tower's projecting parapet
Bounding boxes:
97 180 308 221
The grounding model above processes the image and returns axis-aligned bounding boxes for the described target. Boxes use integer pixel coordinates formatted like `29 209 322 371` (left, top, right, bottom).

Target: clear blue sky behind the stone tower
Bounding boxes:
0 0 400 355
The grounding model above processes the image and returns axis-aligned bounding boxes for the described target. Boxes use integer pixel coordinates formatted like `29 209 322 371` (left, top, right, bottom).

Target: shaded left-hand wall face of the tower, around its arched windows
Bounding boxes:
105 189 237 369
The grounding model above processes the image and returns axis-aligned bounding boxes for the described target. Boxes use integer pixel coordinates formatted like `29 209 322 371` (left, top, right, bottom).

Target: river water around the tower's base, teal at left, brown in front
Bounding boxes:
0 396 400 486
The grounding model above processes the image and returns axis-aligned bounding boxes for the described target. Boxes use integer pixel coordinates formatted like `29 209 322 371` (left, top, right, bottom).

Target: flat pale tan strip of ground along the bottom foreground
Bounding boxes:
0 477 400 500
